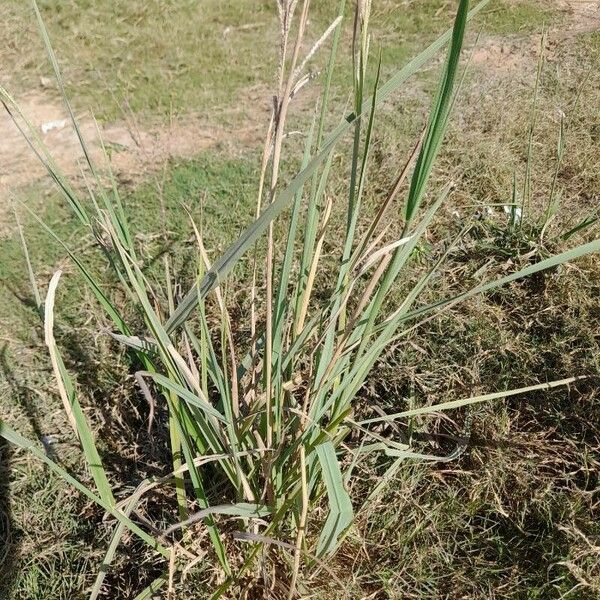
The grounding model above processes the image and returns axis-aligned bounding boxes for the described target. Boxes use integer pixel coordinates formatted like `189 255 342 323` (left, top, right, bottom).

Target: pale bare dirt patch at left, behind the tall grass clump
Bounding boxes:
0 91 264 230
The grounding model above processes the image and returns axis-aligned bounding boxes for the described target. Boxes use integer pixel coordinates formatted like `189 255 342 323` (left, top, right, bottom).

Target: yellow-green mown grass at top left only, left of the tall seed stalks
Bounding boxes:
6 0 277 119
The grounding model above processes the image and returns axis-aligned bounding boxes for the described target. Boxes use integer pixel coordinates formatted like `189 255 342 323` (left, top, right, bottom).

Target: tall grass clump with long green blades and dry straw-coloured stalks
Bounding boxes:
0 2 600 597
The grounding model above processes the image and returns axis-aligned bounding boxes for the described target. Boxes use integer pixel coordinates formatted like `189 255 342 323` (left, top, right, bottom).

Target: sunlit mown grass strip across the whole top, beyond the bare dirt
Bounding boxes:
0 0 557 124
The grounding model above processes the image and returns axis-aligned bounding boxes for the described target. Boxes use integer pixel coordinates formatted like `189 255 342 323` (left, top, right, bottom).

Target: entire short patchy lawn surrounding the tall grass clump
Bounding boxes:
0 0 600 600
